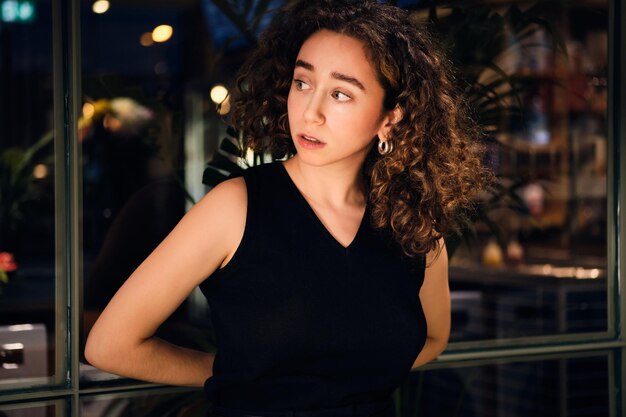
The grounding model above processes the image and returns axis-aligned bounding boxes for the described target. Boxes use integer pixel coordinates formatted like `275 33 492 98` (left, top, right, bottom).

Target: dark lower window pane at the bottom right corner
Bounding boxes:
397 355 612 417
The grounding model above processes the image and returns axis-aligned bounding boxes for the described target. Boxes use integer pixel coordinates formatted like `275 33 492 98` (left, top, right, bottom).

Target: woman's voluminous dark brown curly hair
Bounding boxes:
231 0 490 256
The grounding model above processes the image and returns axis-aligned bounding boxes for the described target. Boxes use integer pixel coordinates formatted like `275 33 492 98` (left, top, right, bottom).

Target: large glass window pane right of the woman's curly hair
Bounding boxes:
437 1 608 341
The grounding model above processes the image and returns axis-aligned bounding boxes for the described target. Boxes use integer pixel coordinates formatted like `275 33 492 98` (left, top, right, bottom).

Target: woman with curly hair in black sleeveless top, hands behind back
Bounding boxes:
86 0 487 417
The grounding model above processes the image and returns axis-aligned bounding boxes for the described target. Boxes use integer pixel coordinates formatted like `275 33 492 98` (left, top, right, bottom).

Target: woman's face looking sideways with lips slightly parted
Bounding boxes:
287 30 390 166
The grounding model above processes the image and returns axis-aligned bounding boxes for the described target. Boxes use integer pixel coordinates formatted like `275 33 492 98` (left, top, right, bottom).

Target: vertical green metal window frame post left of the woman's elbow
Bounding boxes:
52 0 82 415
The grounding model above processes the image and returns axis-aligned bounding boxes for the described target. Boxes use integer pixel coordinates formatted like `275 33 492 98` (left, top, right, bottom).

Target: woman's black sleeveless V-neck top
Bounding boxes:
200 162 426 411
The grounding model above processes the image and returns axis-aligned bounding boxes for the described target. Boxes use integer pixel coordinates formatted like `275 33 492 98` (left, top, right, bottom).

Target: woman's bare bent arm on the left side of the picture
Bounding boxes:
85 178 247 386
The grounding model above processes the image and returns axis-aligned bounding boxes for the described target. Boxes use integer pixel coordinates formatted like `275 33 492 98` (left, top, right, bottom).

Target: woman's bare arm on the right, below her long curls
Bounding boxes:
411 239 451 369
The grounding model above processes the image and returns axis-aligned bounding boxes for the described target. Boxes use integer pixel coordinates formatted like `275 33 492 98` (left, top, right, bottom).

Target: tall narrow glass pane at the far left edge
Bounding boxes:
0 1 58 390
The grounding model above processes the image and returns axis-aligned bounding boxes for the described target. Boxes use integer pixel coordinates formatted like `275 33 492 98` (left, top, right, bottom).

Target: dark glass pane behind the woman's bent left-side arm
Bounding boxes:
79 2 218 383
